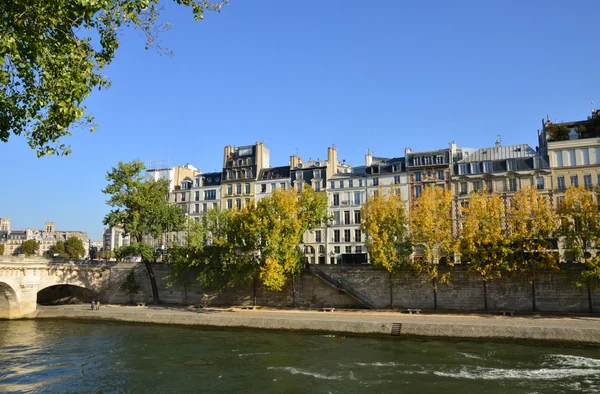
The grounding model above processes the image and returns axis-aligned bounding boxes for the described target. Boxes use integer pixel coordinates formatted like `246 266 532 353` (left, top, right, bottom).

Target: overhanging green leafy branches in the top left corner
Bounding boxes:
0 0 224 157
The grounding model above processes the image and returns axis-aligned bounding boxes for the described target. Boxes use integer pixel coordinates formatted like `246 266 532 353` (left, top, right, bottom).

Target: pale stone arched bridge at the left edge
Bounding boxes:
0 256 110 319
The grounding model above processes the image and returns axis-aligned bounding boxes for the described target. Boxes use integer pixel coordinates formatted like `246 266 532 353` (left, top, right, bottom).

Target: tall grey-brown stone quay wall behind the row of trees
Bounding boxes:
100 263 600 313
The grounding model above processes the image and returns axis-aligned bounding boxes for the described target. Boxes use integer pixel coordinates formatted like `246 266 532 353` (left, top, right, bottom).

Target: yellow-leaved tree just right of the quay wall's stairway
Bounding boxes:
360 188 412 308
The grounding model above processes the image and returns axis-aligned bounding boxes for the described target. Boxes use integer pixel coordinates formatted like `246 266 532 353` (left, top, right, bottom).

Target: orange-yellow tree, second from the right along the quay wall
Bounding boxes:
508 186 559 311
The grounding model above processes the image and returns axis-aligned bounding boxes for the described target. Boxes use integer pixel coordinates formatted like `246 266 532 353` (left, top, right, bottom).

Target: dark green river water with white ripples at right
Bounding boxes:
0 320 600 393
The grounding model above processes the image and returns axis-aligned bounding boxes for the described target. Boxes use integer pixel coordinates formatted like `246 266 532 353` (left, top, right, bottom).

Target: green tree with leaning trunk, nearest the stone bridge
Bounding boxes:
102 160 183 303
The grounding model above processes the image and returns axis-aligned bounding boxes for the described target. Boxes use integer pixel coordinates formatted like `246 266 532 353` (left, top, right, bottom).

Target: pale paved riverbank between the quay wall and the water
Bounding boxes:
29 305 600 344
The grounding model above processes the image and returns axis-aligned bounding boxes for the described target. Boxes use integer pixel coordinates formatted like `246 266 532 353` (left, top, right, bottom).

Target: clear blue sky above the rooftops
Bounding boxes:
0 0 600 240
